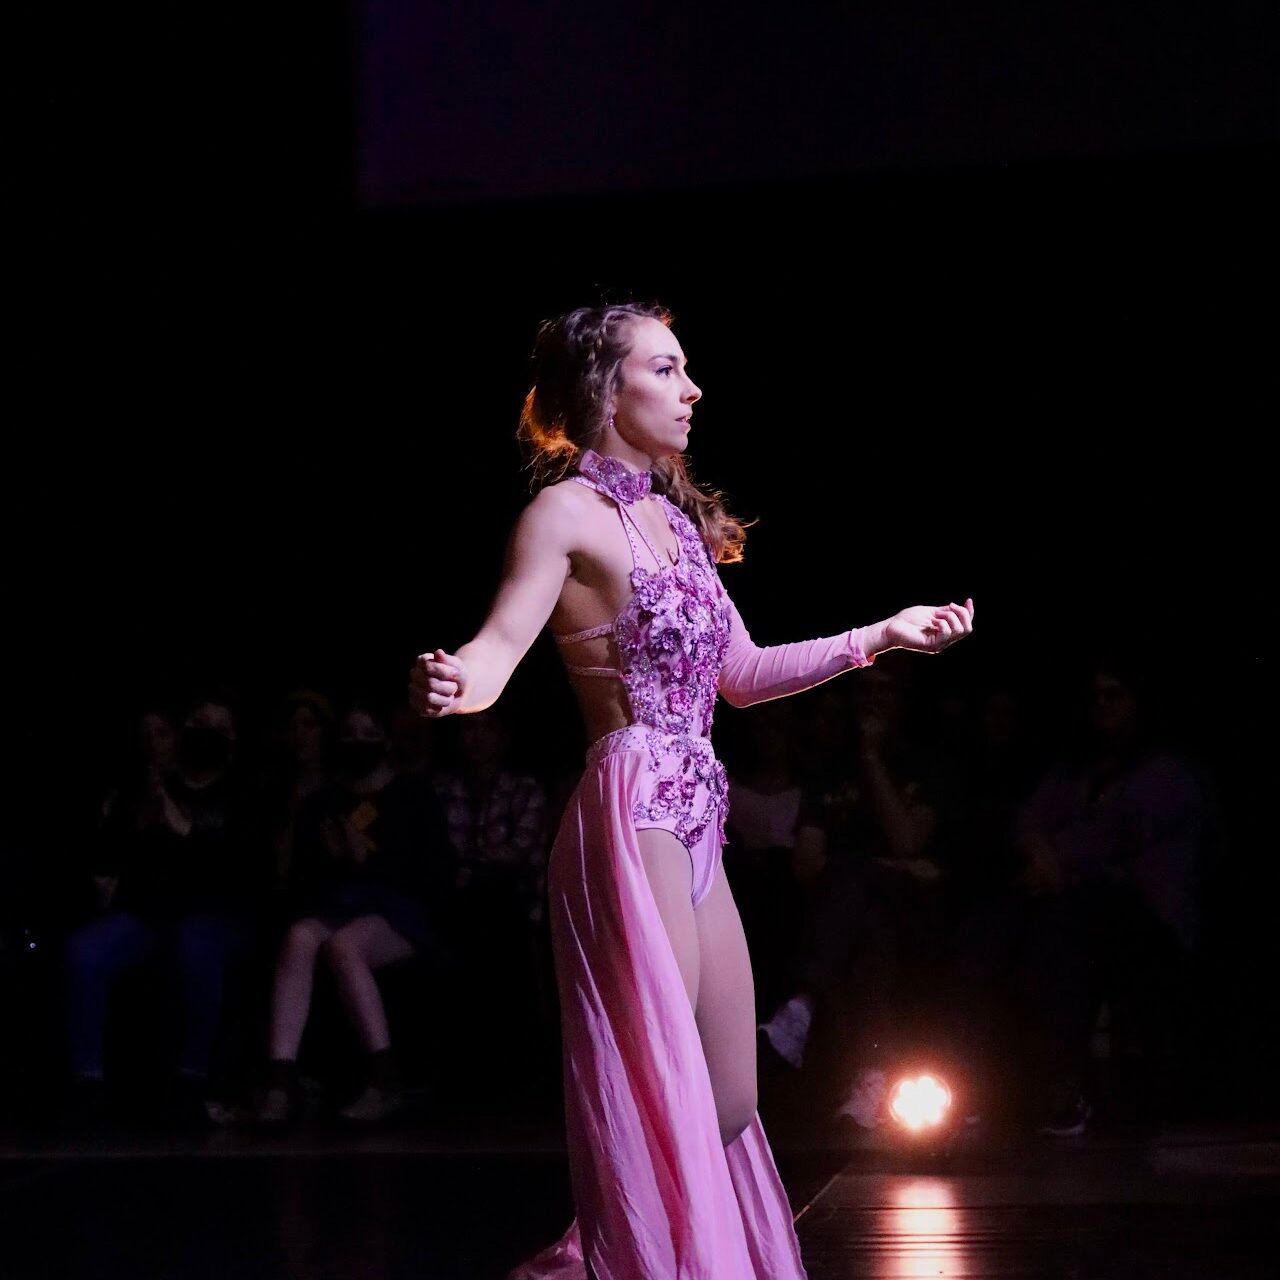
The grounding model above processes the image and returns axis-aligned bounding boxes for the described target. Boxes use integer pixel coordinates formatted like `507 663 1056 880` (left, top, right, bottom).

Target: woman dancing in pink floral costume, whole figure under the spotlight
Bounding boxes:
410 303 973 1280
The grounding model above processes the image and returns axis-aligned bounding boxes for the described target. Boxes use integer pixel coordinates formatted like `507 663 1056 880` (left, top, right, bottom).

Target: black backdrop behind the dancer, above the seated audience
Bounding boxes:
12 0 1280 1090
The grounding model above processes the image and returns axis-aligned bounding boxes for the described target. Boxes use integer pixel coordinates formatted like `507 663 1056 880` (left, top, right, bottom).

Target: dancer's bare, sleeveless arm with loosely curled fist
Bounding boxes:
410 489 577 718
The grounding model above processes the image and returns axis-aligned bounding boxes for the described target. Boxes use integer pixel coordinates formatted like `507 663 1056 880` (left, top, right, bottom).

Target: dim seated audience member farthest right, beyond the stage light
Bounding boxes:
1015 658 1206 1134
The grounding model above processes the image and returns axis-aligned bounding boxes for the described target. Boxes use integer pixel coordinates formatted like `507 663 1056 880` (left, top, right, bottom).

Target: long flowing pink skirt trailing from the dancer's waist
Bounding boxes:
508 726 805 1280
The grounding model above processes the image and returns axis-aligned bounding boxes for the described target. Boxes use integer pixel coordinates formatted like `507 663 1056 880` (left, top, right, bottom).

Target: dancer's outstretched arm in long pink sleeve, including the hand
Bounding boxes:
718 600 973 707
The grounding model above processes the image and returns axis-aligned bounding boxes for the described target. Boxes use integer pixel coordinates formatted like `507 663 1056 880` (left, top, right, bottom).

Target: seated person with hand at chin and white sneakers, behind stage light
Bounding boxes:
760 654 954 1128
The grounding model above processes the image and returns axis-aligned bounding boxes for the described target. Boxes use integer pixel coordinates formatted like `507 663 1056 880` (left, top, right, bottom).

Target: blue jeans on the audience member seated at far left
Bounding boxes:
65 911 250 1075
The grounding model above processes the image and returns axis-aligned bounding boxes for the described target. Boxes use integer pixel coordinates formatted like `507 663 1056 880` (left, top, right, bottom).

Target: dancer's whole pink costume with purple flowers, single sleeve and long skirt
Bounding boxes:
508 451 869 1280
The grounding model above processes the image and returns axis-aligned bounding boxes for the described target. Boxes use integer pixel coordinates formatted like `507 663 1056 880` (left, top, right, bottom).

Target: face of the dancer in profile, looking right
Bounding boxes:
613 316 703 458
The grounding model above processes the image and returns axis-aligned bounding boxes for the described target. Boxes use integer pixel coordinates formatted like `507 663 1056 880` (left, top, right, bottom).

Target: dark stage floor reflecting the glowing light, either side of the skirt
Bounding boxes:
0 1095 1280 1280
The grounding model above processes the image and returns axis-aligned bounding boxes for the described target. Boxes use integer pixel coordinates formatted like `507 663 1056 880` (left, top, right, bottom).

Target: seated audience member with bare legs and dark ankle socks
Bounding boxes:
256 703 448 1126
